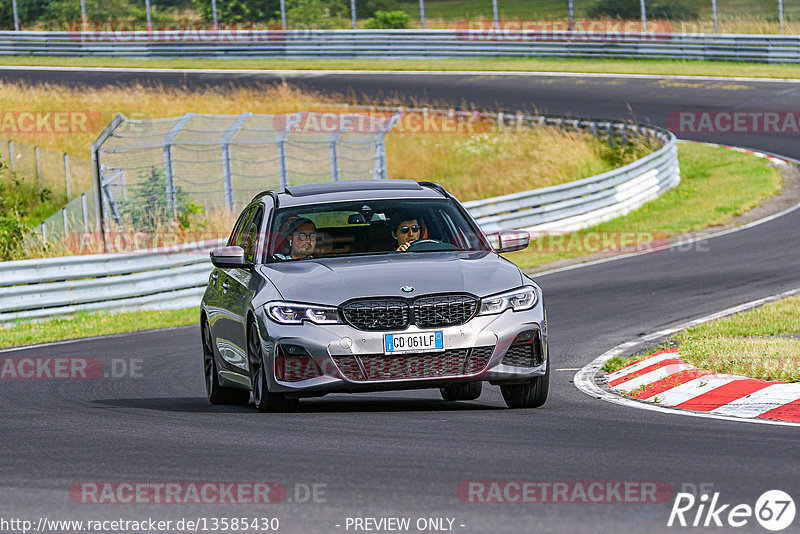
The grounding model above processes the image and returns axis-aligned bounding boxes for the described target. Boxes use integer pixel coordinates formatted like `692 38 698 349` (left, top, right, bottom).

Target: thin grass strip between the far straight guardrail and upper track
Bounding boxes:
3 56 800 78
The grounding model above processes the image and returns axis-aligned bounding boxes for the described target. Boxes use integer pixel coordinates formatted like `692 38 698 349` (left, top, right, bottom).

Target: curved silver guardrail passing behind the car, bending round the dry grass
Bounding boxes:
0 108 680 324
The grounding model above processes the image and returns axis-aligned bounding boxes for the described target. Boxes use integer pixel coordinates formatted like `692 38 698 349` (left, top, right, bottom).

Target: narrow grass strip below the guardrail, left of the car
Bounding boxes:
0 307 200 348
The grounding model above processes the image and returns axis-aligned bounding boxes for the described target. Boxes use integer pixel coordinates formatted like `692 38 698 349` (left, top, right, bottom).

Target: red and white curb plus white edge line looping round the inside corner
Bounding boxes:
574 288 800 428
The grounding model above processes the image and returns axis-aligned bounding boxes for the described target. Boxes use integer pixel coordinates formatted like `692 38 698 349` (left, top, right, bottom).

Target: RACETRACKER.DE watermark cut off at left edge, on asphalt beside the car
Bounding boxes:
0 356 144 380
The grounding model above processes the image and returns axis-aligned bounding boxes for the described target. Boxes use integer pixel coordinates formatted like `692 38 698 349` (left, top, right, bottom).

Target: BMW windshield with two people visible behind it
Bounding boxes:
265 199 491 262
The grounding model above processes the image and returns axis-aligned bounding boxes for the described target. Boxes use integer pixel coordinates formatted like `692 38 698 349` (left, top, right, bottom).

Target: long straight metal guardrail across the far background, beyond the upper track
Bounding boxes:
0 28 800 63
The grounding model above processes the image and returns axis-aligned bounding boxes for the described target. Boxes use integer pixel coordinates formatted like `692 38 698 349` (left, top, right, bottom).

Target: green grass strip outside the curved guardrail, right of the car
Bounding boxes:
506 143 781 268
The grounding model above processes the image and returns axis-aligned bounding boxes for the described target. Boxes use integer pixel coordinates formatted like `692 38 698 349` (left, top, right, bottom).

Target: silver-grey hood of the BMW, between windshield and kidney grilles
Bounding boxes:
259 252 522 306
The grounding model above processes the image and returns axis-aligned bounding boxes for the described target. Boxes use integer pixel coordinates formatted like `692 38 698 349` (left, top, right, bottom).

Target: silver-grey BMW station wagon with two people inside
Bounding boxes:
200 180 550 412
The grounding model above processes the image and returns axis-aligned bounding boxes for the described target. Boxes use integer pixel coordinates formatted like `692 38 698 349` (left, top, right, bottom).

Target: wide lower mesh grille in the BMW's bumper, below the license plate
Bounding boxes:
334 347 494 381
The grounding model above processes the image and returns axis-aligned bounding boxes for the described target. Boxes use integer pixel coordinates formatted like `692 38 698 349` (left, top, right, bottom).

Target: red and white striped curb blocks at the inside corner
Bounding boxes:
606 348 800 423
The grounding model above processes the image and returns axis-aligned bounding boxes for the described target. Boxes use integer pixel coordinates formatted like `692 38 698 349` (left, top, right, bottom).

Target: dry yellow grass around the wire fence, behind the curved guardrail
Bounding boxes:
0 80 652 257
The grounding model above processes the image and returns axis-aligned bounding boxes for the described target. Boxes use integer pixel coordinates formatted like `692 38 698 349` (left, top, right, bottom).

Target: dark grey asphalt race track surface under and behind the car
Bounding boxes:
0 68 800 533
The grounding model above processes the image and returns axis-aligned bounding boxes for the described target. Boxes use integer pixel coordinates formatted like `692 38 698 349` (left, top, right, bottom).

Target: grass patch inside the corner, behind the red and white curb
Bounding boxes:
603 296 800 382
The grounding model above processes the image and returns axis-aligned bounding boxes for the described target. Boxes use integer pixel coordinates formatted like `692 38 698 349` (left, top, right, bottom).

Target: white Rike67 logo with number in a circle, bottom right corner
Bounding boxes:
667 490 796 532
